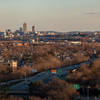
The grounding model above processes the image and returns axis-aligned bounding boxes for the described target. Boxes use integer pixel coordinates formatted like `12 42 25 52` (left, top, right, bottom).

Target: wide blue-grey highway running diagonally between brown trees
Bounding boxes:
9 59 93 94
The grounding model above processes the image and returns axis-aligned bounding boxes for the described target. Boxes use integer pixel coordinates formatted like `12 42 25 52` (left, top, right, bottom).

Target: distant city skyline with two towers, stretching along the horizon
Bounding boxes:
0 23 100 44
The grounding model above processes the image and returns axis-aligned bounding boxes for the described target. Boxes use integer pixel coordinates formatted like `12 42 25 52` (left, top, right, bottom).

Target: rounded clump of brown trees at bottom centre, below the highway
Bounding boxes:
41 79 76 100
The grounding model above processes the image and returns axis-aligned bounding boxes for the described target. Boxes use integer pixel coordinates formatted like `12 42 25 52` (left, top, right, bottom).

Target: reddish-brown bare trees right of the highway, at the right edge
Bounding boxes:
67 59 100 85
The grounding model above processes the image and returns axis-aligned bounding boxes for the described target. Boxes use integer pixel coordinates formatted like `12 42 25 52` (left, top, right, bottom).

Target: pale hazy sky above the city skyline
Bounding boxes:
0 0 100 32
